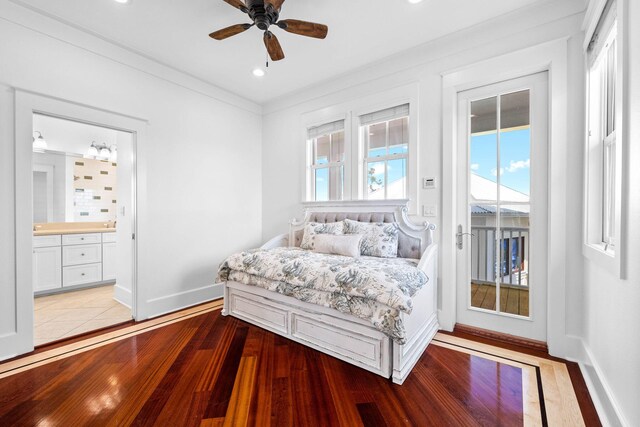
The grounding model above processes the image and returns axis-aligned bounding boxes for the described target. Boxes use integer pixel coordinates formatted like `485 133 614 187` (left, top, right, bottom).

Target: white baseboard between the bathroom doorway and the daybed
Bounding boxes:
143 283 224 320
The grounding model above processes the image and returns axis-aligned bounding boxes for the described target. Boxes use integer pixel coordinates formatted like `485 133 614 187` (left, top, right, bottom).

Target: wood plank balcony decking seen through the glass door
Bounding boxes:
471 283 529 317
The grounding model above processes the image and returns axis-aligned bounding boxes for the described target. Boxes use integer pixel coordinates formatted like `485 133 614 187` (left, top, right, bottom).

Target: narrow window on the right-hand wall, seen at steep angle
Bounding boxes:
586 1 618 253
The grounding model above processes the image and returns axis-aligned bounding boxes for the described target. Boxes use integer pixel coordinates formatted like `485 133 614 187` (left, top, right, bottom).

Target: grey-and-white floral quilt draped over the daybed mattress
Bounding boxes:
218 247 429 344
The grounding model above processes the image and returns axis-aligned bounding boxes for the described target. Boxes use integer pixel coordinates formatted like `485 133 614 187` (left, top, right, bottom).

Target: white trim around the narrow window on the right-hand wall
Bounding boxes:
582 0 628 279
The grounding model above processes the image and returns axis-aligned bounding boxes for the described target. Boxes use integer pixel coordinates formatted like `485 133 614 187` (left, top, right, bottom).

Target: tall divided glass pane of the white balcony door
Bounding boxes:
469 90 531 317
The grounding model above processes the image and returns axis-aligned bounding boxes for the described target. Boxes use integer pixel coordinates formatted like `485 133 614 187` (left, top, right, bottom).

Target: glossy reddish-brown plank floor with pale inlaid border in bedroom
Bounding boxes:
0 305 596 426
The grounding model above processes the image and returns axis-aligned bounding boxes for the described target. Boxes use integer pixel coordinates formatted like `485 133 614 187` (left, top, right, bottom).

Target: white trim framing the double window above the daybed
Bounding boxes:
300 82 420 215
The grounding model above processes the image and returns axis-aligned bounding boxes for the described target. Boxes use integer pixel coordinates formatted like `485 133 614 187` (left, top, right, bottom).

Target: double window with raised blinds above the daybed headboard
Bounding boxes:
300 89 419 215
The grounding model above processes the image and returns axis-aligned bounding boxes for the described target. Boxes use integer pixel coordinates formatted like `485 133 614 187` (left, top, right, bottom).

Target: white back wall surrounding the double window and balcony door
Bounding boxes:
263 1 584 344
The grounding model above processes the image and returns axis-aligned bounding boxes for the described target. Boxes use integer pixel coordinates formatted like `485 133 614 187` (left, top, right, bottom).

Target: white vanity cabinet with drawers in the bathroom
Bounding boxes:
33 232 116 293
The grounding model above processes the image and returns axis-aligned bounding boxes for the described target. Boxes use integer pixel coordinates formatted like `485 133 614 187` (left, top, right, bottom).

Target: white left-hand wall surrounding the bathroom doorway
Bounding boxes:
0 0 262 342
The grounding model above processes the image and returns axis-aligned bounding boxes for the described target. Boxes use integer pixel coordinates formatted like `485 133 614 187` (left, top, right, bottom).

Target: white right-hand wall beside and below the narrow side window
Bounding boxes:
584 0 640 426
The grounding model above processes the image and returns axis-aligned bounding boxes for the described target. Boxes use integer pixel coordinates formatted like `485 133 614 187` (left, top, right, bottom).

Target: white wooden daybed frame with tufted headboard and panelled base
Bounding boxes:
222 200 439 384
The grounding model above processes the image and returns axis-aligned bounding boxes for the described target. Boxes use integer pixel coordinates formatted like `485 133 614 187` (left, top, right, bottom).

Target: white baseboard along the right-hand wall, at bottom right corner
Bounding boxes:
578 340 631 427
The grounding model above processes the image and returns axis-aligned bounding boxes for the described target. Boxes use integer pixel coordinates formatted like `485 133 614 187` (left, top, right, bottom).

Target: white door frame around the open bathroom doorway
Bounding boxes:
10 89 148 360
